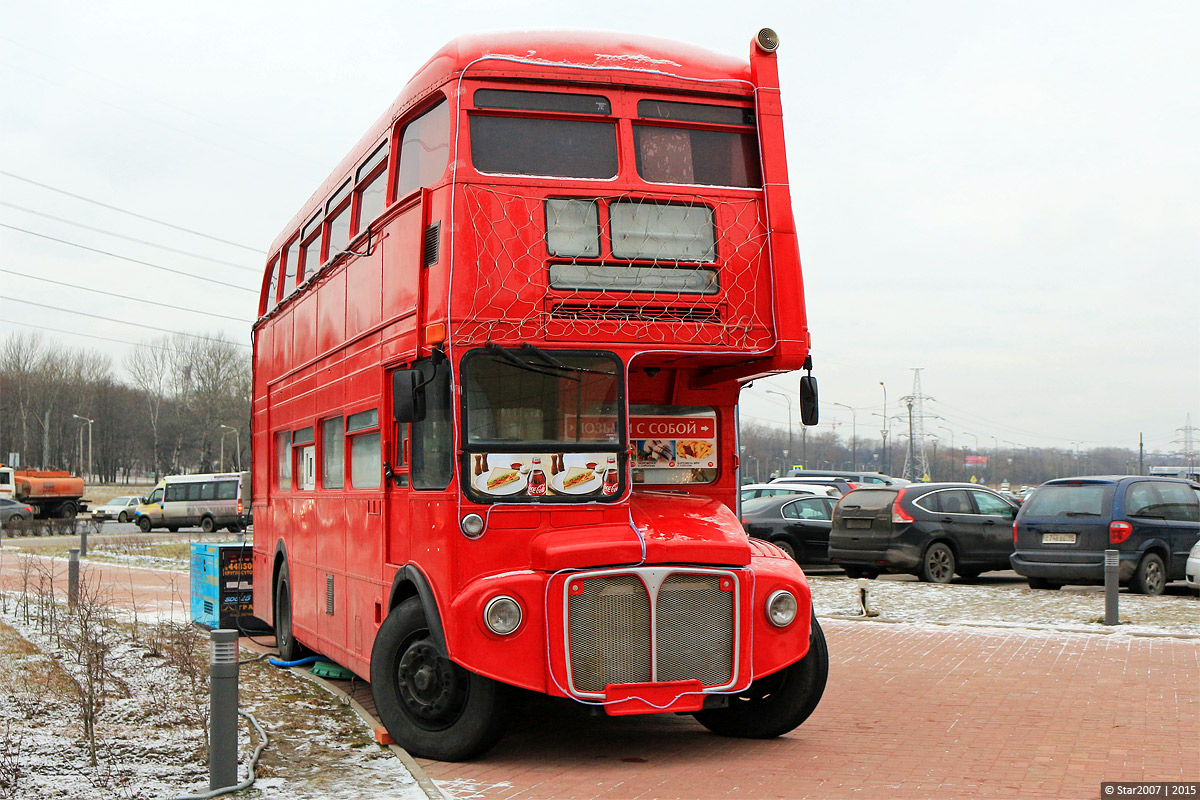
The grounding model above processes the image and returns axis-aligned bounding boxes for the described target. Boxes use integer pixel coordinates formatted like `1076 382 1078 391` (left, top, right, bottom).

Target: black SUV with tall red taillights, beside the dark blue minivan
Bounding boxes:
829 483 1016 583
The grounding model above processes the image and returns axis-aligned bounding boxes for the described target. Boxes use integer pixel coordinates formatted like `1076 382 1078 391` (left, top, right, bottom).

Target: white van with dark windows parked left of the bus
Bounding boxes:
134 473 251 534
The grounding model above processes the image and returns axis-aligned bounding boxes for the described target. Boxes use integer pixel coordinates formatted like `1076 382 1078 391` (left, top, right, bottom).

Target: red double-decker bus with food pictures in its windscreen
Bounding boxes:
253 30 828 760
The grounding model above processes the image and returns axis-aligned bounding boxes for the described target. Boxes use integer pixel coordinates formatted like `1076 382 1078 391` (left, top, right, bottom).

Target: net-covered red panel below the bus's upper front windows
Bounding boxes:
451 185 772 349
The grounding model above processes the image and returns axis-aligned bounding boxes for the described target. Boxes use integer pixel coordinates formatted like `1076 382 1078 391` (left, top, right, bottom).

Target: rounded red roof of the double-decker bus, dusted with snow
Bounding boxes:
268 30 750 256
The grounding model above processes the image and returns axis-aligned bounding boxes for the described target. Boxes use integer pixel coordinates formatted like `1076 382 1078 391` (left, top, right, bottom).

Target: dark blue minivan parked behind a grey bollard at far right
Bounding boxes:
1012 475 1200 595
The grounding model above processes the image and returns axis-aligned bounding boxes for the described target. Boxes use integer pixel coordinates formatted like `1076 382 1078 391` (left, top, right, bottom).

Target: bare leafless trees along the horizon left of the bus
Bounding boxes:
0 332 251 483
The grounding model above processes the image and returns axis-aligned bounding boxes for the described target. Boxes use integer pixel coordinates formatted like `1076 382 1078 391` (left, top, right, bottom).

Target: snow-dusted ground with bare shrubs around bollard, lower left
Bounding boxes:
0 591 426 800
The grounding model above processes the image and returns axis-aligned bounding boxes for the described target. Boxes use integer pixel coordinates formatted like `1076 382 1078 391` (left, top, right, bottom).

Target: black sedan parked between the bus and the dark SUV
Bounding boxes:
742 494 836 564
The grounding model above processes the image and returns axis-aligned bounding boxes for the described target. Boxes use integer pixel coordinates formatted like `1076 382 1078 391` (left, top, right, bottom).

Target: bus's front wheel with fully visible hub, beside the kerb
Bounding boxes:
371 597 512 762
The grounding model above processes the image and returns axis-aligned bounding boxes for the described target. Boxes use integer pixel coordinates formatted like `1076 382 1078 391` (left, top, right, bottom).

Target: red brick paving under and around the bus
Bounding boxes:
11 558 1200 800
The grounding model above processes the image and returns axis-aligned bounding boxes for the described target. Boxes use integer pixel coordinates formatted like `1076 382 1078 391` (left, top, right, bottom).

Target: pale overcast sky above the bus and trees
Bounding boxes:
0 0 1200 451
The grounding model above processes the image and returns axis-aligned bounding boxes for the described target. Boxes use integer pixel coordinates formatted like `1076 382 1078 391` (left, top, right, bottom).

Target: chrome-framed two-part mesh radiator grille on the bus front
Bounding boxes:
563 567 740 698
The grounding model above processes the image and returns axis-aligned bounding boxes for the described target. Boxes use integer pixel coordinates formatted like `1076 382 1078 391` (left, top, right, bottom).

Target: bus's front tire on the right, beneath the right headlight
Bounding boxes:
692 616 829 739
